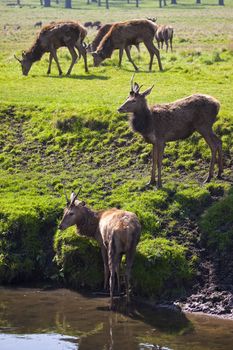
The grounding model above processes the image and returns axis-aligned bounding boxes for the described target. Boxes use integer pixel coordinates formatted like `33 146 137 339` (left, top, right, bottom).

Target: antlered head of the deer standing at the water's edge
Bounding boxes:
58 187 85 231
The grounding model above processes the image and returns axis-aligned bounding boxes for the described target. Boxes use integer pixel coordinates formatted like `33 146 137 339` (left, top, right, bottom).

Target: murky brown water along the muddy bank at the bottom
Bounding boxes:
0 288 233 350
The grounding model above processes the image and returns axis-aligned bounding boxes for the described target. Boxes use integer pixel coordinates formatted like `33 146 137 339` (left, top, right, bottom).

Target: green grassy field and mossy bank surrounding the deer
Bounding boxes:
0 0 233 297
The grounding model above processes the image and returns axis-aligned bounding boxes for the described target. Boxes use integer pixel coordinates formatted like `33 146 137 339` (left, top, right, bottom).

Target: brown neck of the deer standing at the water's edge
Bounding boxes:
76 207 99 239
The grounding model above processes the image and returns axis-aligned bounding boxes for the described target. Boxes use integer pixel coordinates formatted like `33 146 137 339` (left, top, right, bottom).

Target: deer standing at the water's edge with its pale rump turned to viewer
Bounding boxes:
58 191 141 309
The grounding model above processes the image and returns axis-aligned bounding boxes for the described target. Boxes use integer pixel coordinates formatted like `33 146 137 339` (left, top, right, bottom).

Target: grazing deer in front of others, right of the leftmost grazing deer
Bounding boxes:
92 19 163 71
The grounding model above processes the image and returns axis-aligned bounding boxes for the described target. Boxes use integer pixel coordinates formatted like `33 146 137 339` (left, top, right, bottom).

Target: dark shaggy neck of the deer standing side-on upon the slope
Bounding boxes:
130 105 152 138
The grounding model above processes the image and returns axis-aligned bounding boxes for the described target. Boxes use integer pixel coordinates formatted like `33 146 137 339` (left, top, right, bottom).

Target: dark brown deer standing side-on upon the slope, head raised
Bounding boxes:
118 77 223 188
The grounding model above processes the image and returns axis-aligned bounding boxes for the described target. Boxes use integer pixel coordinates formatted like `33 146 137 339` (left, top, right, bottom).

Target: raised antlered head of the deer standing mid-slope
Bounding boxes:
118 75 154 113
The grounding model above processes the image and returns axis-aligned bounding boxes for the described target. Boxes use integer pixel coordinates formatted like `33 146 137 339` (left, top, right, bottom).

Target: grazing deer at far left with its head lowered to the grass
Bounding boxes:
15 21 88 76
